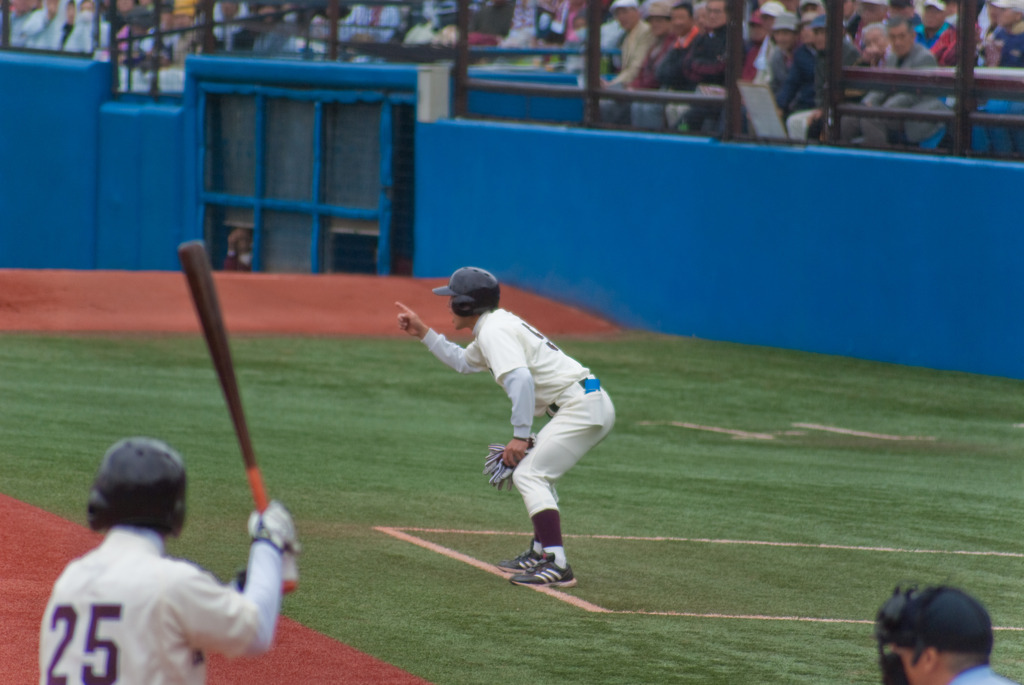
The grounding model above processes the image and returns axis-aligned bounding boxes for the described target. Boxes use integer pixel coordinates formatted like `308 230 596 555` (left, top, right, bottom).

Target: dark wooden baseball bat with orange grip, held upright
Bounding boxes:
178 241 268 512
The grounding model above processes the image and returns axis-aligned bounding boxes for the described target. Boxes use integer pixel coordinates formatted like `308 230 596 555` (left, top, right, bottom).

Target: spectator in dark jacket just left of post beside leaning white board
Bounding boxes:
683 0 729 133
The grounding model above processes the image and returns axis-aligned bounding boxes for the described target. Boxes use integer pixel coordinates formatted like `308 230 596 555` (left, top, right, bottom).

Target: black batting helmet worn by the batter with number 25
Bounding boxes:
89 437 185 536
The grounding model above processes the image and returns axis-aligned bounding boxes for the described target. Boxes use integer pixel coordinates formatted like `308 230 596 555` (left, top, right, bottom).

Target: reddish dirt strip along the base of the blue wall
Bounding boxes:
0 269 617 337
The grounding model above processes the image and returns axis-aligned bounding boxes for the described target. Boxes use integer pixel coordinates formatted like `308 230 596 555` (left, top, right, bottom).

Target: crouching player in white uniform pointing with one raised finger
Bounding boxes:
395 266 615 588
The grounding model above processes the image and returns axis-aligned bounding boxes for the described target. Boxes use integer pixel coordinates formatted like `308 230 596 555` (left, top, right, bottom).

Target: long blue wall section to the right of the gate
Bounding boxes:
415 121 1024 378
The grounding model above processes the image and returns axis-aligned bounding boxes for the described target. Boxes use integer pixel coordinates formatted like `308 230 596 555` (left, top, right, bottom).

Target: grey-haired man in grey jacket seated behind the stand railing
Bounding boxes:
840 16 948 147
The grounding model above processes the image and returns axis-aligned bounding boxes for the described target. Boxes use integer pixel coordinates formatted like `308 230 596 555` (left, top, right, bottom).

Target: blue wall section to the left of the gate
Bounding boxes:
0 52 188 269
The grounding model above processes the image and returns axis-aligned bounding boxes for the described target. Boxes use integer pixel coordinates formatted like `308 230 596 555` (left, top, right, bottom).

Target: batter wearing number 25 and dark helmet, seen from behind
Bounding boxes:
39 437 298 685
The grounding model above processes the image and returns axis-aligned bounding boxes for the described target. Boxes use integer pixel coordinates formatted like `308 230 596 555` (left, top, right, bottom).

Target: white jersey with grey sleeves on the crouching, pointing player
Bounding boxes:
423 309 590 416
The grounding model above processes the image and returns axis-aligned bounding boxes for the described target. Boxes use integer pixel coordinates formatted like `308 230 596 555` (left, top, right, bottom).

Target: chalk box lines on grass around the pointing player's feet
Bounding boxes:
374 525 1024 632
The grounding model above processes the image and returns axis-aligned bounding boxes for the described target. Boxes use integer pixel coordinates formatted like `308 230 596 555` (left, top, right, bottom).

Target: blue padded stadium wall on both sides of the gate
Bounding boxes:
0 52 1024 378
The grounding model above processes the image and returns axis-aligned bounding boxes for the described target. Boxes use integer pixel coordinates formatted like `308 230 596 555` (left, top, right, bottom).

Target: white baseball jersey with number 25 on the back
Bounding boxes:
39 527 264 685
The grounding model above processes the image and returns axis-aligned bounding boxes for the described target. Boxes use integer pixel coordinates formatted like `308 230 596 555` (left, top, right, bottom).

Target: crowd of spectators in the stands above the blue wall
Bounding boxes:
0 0 1024 148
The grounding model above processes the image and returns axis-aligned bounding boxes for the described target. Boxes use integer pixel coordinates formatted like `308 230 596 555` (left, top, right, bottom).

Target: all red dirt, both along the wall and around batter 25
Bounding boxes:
0 269 620 685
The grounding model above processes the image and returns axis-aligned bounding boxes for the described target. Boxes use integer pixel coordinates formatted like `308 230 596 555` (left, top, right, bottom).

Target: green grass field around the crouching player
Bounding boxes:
0 334 1024 685
